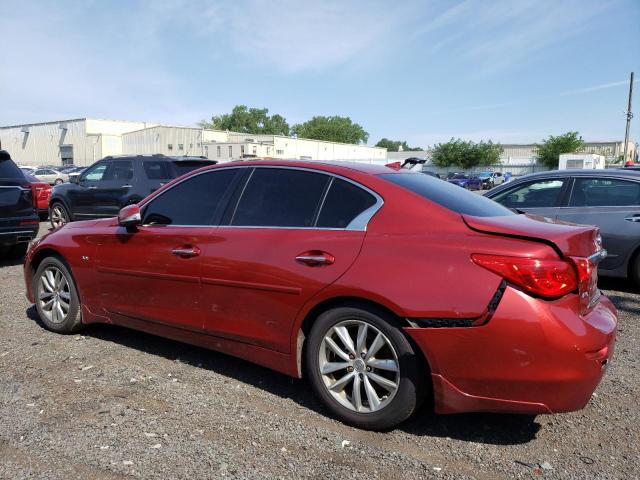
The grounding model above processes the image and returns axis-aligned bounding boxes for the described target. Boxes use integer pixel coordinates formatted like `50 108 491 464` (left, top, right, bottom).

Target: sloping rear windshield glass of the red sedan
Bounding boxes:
380 173 515 217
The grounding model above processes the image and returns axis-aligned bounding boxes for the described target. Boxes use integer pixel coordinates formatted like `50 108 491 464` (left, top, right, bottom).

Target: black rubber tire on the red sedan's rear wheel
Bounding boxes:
304 307 429 430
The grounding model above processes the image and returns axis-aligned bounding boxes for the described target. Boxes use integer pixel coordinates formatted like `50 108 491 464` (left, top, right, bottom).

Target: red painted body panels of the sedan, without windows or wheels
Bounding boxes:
25 161 617 413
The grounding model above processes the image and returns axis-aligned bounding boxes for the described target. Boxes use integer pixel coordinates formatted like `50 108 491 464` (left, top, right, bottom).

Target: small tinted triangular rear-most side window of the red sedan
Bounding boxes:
316 178 376 228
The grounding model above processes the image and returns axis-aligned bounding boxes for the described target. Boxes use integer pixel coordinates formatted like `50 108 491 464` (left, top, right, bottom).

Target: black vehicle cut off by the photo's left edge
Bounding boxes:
0 150 39 258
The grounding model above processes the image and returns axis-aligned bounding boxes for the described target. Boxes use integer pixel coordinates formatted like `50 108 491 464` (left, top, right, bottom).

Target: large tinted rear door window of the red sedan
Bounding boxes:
231 168 331 227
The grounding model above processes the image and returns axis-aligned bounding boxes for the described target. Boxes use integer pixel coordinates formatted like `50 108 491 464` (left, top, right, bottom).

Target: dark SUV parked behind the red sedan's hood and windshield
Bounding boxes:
49 155 216 228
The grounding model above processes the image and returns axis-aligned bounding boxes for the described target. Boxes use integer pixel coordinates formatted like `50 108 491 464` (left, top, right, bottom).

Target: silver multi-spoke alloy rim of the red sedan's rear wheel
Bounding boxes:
318 320 400 413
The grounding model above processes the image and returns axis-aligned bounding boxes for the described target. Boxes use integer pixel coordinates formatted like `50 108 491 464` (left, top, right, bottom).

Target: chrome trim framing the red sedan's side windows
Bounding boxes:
141 165 384 232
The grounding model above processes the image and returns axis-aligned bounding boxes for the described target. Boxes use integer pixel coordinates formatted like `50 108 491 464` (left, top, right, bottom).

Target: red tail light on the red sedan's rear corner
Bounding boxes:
471 254 578 298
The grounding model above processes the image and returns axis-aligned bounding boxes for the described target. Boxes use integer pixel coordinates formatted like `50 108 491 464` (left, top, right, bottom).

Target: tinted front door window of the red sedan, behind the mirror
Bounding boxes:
142 169 237 226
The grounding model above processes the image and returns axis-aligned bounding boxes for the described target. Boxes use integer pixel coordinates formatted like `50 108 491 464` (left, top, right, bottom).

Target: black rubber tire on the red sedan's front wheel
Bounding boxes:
33 257 82 333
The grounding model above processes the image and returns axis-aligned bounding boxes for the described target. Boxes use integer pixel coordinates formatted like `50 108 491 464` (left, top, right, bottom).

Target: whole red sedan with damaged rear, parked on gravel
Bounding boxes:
24 161 617 429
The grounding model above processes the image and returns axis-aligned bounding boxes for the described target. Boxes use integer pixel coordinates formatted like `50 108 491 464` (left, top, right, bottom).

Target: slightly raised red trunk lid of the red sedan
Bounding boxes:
462 214 606 315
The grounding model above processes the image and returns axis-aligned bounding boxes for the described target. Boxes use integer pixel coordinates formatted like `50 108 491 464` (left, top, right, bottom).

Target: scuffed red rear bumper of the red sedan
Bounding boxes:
406 287 617 414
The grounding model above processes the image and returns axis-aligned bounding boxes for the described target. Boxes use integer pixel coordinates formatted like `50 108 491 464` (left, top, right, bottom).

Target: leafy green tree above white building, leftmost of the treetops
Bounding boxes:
198 105 290 135
